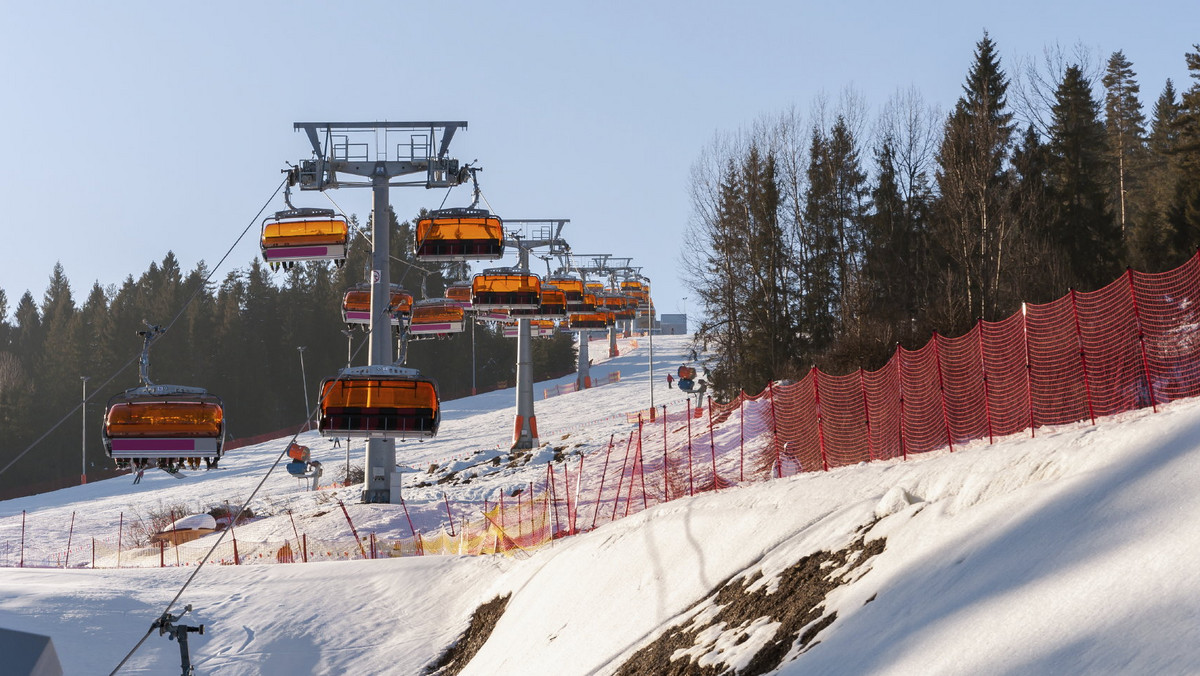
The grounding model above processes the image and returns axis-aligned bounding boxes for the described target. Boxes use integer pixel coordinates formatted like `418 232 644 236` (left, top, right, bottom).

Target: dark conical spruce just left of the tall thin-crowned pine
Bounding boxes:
1049 66 1121 291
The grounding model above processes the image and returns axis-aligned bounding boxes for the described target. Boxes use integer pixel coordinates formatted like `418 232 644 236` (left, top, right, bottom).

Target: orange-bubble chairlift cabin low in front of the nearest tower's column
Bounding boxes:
318 365 442 439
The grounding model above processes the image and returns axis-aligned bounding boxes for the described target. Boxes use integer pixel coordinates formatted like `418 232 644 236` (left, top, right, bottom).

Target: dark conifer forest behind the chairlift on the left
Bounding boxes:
0 206 576 490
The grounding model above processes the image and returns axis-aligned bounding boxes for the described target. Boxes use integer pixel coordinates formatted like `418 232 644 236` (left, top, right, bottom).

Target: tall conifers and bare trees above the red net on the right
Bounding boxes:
685 34 1200 394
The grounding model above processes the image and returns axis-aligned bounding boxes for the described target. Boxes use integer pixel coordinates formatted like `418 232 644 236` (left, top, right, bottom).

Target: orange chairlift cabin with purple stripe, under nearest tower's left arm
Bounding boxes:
260 209 350 270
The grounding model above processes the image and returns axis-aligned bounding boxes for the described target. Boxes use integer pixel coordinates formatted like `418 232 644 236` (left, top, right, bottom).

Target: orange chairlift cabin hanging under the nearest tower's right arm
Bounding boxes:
415 208 504 261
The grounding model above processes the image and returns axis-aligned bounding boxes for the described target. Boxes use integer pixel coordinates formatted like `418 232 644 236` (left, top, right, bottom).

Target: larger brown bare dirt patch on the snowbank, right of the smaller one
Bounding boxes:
617 528 886 676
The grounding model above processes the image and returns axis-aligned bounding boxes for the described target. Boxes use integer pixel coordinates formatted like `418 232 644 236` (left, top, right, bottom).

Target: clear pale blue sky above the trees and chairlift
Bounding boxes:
0 0 1200 321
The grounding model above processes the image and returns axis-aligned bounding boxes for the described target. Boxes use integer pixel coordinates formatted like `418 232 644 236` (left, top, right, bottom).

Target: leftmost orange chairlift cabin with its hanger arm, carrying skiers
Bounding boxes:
101 324 226 473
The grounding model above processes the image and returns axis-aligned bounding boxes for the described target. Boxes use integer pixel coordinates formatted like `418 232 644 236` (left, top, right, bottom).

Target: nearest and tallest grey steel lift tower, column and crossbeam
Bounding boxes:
289 121 470 503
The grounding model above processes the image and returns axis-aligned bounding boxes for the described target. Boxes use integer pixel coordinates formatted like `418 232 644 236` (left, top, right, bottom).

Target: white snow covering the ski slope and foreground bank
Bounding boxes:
0 336 1200 675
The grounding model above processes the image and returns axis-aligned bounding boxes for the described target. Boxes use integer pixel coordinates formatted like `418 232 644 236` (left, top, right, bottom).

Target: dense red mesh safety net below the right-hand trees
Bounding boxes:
769 257 1200 475
